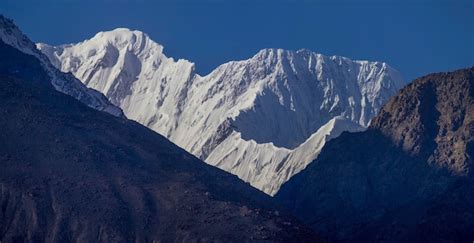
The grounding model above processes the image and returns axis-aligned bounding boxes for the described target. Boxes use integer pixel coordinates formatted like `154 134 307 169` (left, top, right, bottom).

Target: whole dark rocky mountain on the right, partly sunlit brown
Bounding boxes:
276 68 474 242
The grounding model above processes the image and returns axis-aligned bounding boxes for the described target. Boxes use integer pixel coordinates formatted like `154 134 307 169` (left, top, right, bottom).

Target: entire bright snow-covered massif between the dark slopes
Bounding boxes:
37 28 404 195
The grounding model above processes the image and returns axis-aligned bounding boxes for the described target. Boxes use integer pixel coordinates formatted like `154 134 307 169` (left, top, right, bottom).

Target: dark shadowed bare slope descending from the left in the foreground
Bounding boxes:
0 39 317 242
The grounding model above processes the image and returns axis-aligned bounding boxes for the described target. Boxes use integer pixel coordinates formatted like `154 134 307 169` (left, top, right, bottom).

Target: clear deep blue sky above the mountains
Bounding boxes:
0 0 474 80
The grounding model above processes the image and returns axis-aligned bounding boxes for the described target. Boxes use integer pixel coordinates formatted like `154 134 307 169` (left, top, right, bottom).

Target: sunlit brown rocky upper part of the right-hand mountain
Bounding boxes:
372 68 474 175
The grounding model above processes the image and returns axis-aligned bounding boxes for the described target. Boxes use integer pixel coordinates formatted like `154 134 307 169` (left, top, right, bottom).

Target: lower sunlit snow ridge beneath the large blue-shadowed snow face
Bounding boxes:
207 117 364 195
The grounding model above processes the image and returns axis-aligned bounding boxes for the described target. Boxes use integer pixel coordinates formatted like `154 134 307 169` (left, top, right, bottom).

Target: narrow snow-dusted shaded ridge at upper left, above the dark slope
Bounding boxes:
0 15 123 116
